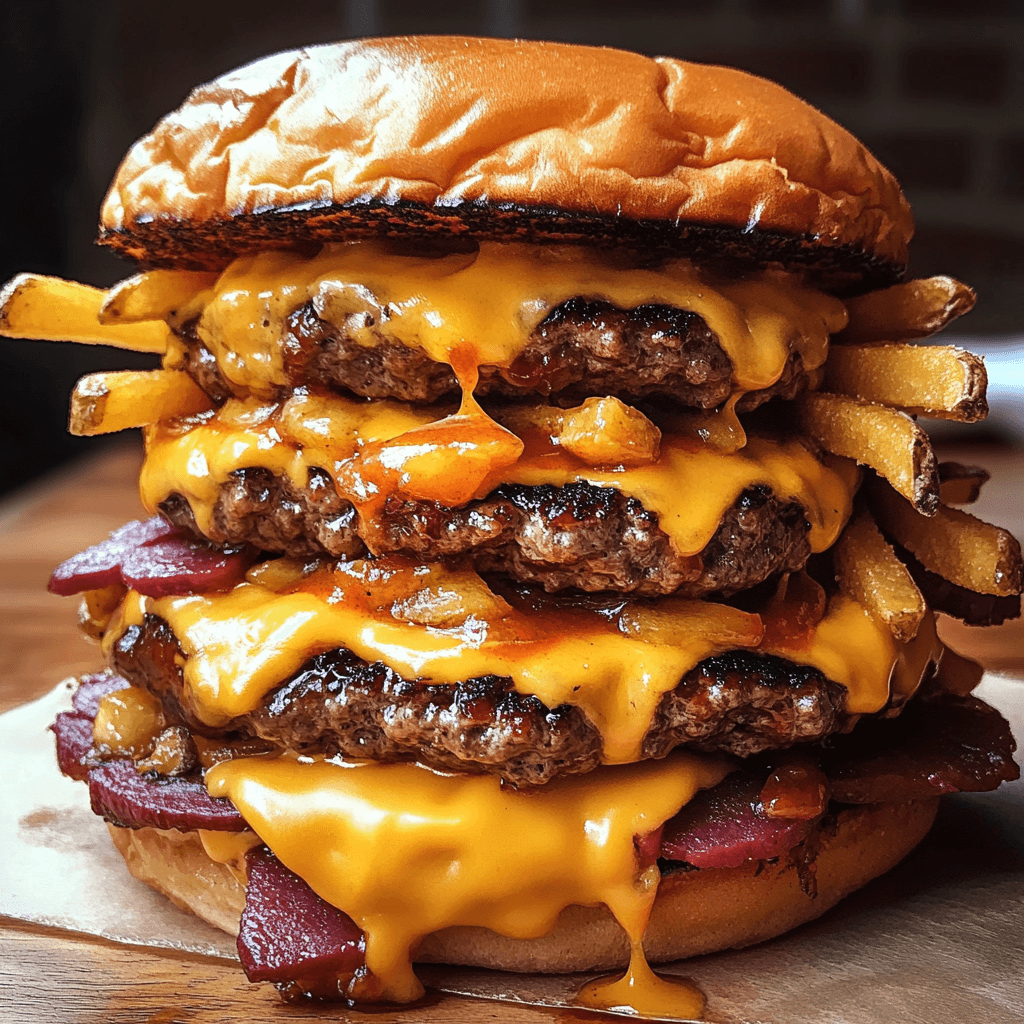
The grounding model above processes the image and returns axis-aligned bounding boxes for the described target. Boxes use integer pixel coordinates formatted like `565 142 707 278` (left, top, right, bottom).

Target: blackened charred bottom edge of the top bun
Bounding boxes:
99 200 906 294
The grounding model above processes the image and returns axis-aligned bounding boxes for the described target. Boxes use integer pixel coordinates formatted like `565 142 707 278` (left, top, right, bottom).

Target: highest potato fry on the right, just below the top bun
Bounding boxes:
833 278 975 344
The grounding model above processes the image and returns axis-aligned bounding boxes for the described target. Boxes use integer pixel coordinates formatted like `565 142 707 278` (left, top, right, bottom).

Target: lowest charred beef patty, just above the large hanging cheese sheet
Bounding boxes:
113 615 850 785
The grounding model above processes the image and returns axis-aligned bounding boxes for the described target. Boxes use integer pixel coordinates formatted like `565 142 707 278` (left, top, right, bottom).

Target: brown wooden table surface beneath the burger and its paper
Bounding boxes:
0 444 1024 1024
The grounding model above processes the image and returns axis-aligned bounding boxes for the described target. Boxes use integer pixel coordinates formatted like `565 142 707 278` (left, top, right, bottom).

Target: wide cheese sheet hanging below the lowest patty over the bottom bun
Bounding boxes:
207 752 731 1001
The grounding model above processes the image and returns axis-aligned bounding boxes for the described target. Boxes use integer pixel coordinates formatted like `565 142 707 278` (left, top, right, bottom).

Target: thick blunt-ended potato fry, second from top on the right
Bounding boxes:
824 345 988 423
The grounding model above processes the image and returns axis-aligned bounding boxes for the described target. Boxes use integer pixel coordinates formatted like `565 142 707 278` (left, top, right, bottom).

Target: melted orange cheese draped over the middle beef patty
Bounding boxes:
139 393 858 555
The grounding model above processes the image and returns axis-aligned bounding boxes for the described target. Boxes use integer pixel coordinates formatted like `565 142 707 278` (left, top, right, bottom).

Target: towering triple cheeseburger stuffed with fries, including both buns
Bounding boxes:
0 37 1021 1017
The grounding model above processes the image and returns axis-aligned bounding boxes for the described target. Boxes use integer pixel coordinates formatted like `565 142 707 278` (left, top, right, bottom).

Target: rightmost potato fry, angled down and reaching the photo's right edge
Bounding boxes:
870 481 1022 597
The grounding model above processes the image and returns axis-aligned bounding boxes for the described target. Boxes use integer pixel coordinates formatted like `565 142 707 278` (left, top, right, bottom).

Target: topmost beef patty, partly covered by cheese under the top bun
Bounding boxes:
180 298 808 412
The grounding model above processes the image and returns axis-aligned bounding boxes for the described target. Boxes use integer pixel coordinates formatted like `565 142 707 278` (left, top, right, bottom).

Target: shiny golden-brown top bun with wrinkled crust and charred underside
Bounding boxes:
100 36 913 287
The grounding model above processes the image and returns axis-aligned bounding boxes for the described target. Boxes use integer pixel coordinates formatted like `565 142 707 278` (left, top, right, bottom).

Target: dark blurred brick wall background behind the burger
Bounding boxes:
0 0 1024 489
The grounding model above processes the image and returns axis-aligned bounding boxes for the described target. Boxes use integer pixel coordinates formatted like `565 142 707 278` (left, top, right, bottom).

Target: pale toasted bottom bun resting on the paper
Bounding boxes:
111 798 939 974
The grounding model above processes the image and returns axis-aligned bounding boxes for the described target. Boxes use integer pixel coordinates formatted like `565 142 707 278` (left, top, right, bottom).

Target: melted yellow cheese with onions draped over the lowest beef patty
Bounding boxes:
103 560 934 763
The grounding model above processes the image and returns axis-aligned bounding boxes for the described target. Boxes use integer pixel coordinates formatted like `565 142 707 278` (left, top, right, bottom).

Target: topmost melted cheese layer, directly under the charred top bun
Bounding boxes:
161 242 847 396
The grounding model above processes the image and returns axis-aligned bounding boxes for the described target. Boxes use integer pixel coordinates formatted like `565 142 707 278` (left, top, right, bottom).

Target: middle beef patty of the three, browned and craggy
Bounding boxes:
160 481 810 597
